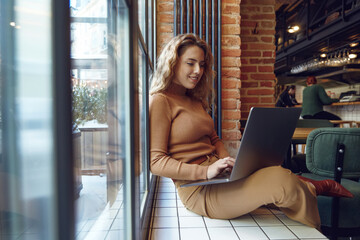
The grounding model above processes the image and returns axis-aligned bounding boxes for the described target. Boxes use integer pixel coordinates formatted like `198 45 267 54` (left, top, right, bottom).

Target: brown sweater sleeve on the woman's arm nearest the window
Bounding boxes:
149 94 208 180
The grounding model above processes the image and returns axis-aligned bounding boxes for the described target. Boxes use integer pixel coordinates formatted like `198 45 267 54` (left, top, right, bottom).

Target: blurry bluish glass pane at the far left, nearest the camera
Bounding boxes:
0 0 57 240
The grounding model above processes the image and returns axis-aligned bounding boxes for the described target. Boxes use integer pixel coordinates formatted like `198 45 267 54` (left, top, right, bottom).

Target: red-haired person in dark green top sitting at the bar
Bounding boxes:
301 76 341 120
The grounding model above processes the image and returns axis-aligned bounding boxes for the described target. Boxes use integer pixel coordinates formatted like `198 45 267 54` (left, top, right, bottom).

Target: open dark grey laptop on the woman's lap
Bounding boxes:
181 107 301 187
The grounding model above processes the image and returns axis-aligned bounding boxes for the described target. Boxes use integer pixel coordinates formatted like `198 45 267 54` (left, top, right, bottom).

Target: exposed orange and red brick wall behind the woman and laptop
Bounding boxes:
157 0 275 156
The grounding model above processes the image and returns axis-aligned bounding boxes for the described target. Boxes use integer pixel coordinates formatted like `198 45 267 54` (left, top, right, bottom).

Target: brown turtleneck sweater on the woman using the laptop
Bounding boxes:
149 85 229 180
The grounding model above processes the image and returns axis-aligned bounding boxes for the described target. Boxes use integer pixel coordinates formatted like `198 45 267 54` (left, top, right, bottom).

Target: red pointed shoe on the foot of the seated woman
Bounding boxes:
297 175 354 198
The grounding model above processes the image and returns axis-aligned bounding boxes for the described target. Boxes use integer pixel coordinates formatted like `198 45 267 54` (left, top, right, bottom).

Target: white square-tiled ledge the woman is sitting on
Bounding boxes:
150 178 327 240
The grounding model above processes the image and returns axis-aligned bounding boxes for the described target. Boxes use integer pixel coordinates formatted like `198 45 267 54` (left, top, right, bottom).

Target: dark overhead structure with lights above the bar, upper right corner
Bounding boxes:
275 0 360 84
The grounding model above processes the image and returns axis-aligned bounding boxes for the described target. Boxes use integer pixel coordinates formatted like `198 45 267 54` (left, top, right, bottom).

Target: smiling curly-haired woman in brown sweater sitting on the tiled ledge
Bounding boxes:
150 34 351 228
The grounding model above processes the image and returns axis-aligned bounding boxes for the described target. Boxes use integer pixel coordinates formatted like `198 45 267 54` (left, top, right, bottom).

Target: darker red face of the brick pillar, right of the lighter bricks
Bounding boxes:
240 0 276 120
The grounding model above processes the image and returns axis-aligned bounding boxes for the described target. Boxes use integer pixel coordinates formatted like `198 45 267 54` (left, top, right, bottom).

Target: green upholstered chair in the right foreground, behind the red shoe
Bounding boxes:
302 128 360 239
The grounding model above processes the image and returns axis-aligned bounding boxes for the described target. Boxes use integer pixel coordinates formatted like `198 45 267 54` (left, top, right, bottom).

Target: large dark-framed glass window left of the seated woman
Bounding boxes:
0 0 155 240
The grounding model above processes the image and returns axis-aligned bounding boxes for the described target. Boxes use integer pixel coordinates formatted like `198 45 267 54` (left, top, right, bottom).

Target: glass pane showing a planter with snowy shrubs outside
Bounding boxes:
71 0 129 239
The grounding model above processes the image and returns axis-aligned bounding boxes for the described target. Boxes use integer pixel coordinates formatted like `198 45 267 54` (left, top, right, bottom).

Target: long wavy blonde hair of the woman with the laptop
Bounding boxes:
150 34 215 111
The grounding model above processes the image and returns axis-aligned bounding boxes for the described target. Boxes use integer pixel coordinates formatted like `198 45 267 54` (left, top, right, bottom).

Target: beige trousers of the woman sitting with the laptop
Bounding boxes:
174 157 320 229
